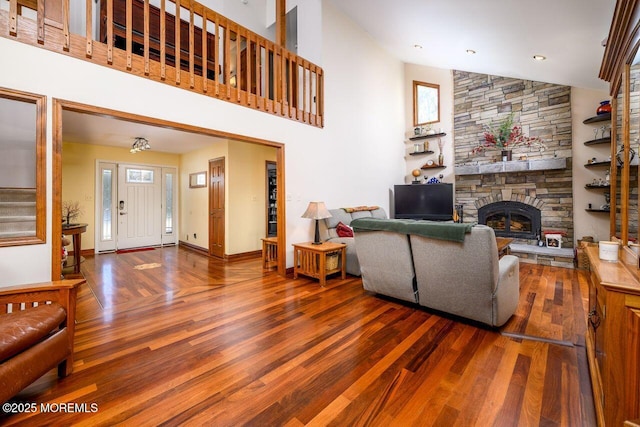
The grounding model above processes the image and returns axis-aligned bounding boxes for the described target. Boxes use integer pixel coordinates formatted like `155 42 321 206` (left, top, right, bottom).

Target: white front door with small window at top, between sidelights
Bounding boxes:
116 165 163 249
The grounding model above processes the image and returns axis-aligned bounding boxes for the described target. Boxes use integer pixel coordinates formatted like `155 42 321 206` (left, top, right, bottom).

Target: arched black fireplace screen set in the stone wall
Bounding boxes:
478 202 541 239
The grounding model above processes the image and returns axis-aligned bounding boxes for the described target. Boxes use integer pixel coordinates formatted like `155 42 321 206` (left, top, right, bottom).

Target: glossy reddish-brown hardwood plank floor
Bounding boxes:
0 248 595 426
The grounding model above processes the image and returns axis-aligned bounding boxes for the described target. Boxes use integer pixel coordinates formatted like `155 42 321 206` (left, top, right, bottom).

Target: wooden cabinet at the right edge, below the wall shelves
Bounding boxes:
586 247 640 426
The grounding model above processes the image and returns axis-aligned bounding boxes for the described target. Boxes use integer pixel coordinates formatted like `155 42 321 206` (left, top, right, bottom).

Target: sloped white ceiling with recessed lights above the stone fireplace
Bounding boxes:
330 0 616 91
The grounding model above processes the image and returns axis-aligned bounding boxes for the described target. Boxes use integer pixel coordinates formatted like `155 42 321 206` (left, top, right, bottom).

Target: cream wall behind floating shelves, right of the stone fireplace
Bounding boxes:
571 87 611 243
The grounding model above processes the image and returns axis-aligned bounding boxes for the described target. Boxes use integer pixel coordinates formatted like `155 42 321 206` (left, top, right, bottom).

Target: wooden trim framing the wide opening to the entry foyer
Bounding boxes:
51 98 286 280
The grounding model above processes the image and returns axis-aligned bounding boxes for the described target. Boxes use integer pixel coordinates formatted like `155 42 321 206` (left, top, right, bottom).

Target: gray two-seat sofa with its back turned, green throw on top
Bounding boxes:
351 220 520 327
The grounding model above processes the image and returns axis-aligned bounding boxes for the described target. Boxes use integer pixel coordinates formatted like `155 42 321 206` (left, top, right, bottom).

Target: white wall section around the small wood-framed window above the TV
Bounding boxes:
404 64 455 184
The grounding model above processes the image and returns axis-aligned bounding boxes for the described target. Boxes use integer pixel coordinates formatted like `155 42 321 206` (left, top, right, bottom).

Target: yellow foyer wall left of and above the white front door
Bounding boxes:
62 142 180 251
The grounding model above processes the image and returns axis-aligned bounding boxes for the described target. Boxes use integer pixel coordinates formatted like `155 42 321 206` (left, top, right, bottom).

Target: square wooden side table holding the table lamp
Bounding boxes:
293 242 347 286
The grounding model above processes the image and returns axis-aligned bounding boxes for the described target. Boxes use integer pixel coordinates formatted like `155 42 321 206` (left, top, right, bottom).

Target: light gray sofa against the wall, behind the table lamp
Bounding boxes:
320 207 387 276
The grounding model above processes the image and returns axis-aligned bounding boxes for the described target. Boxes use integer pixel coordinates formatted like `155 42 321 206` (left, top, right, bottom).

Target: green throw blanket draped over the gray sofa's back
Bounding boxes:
351 218 474 242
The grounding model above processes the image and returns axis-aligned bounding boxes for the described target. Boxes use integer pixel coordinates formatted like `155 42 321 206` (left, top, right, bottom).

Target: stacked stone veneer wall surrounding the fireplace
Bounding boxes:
453 71 573 247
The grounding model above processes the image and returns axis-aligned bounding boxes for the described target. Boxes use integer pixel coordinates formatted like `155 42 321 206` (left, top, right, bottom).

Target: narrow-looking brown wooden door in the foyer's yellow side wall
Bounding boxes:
209 157 225 258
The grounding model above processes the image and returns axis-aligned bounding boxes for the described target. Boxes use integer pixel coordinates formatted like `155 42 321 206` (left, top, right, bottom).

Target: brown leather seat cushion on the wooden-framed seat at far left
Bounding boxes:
0 303 67 362
